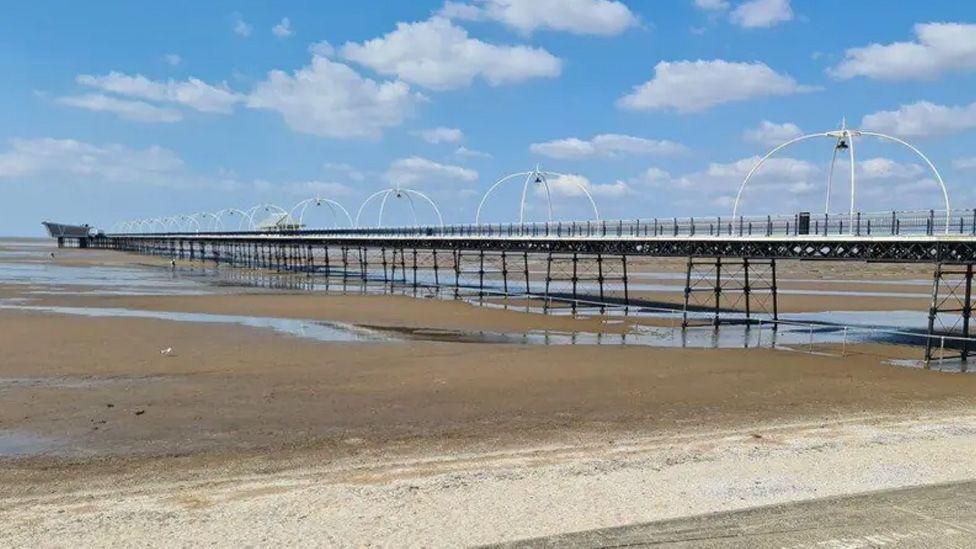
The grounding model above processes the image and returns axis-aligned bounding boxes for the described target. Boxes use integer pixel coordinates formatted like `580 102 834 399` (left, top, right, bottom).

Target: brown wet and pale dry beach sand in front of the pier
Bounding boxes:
0 244 976 546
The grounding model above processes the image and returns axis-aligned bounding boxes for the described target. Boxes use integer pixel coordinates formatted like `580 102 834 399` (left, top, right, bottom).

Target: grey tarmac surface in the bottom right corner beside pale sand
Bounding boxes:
501 481 976 549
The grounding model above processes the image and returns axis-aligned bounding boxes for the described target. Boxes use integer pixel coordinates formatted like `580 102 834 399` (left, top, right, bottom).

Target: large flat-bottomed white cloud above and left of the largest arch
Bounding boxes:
617 59 815 113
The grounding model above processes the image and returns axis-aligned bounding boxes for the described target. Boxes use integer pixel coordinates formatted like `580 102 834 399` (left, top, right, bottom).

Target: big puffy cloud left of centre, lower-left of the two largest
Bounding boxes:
247 56 423 139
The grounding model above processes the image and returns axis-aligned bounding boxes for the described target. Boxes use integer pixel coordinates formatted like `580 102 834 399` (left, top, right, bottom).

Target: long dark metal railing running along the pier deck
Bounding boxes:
112 209 976 238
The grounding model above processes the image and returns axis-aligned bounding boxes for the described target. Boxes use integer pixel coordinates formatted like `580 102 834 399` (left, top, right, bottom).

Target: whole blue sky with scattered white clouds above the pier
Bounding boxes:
0 0 976 236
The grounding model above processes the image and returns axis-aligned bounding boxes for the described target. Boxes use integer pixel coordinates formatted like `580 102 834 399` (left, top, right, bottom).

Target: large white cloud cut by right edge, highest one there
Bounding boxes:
827 23 976 80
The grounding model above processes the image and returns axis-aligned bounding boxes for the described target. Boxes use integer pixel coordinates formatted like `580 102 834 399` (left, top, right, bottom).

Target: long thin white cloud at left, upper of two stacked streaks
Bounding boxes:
75 71 241 113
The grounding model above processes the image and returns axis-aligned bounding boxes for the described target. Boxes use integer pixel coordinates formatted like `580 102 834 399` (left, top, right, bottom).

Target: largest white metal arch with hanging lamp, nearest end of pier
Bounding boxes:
732 121 952 234
